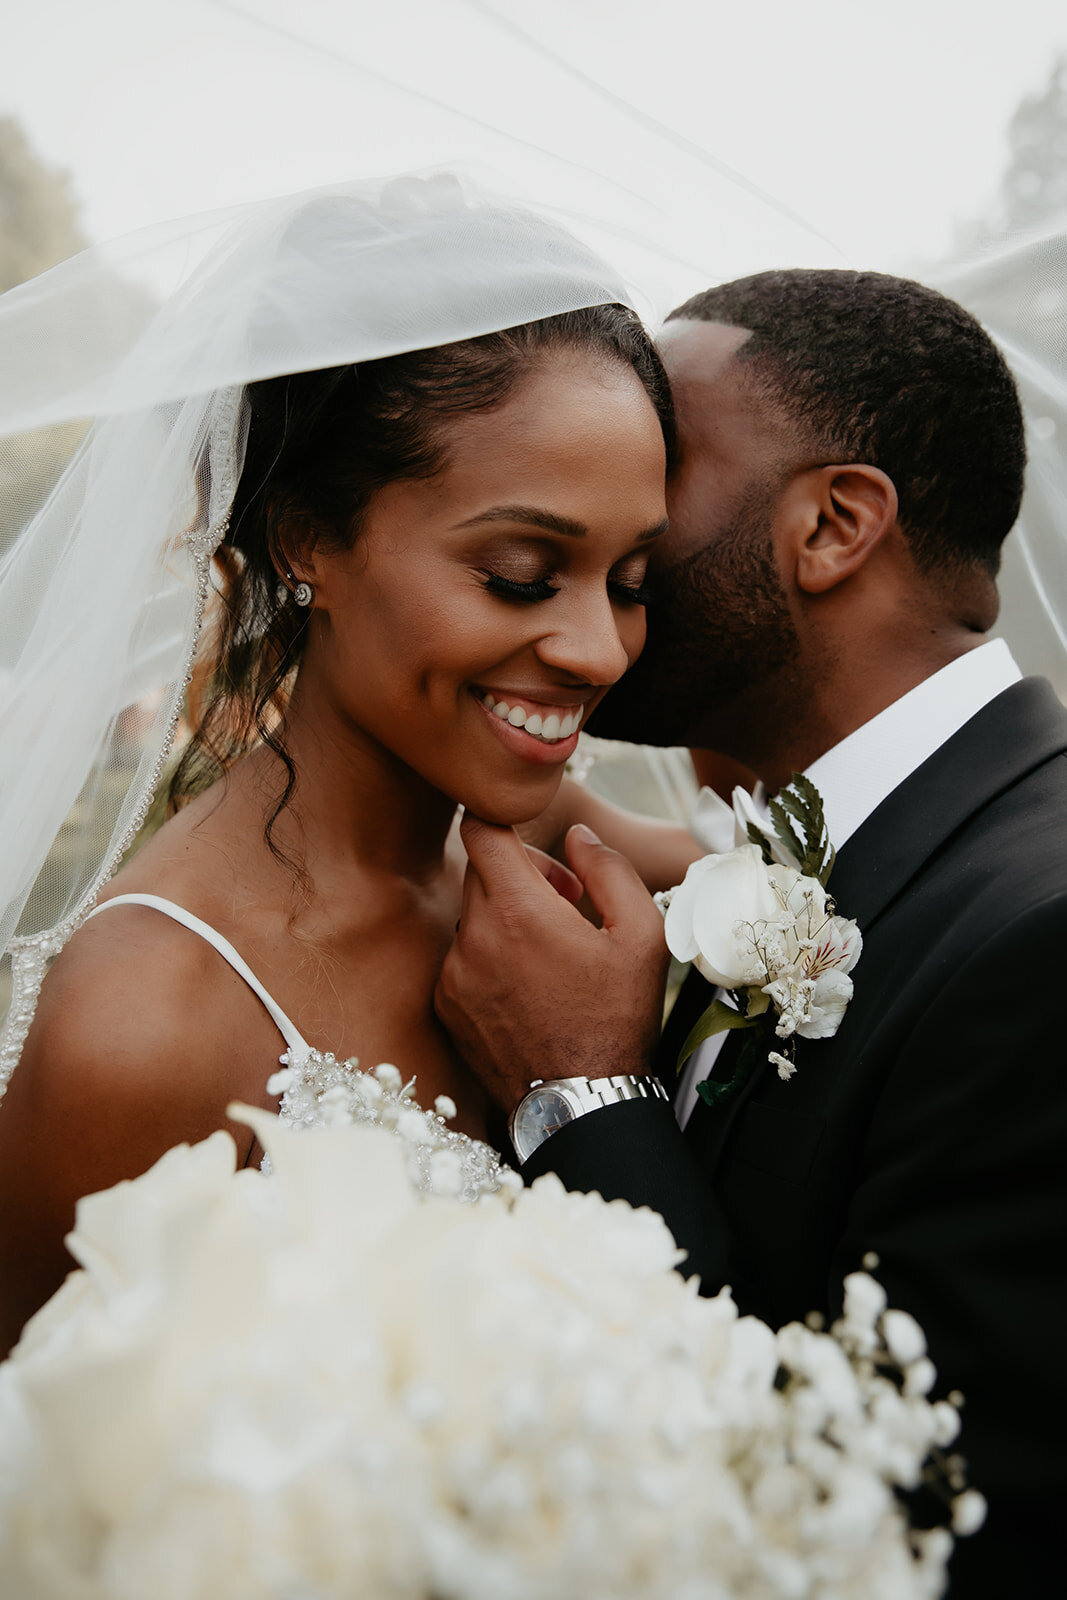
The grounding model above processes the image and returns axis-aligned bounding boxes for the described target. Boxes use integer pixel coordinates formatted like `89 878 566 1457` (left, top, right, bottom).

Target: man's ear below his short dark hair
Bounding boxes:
782 462 897 595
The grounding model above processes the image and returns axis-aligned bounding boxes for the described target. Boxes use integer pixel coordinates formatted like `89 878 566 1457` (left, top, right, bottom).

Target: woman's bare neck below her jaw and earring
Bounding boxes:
254 683 456 880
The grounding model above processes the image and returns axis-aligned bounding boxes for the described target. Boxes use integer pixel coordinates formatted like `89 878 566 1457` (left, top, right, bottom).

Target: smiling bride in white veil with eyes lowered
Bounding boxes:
0 182 696 1344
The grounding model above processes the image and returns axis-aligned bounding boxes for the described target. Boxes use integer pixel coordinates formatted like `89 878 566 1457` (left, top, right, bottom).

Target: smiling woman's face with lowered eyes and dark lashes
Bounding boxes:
282 350 665 822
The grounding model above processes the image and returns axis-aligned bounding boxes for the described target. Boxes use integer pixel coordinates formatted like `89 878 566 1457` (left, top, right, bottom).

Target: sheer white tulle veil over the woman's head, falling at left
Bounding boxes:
0 174 639 1090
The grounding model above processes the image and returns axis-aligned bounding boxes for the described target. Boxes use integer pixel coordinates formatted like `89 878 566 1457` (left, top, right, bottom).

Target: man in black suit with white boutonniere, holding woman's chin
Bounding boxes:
437 272 1067 1600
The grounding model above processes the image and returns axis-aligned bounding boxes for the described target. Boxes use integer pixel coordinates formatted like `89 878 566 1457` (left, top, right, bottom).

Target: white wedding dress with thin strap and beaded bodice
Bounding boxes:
86 894 512 1202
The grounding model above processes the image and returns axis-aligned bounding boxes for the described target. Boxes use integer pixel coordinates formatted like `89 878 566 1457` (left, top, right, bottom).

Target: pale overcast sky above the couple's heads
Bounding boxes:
0 0 1067 308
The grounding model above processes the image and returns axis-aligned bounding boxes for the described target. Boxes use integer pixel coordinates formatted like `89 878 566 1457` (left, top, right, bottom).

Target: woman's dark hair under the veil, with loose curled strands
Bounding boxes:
170 304 673 854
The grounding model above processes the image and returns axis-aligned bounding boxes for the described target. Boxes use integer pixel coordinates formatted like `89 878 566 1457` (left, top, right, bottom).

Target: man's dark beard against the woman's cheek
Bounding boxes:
589 486 798 760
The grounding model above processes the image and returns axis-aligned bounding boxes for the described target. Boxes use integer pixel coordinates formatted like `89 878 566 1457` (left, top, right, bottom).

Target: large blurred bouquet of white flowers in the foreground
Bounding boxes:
0 1112 966 1600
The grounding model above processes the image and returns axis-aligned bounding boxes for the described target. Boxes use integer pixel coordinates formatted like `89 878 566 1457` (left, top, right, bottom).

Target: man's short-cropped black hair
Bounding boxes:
669 269 1025 576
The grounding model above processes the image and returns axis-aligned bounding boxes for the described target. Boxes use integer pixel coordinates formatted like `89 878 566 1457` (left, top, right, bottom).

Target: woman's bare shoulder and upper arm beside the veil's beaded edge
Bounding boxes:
0 906 277 1352
